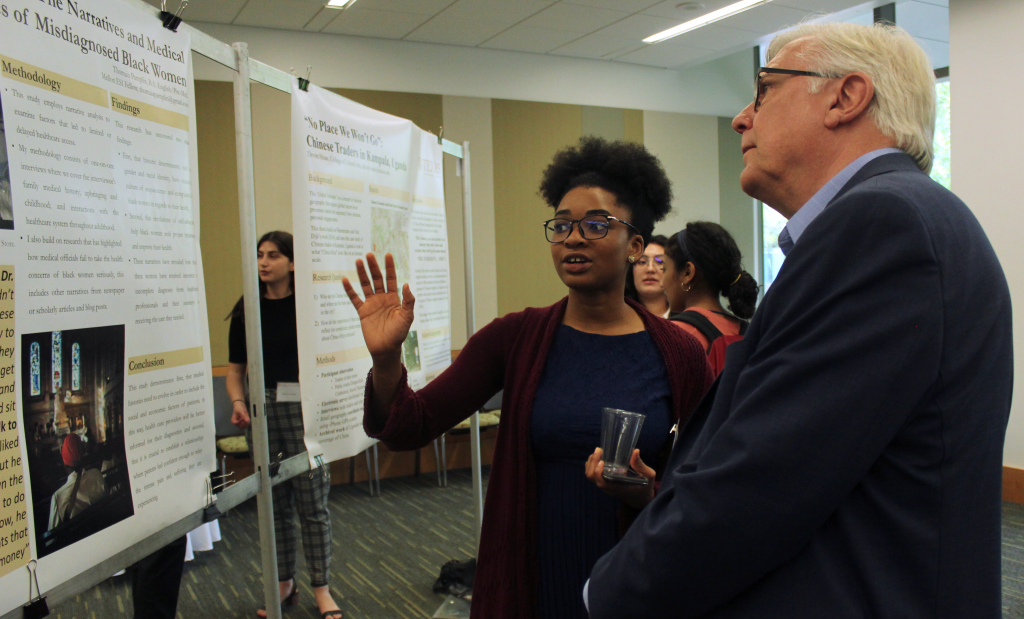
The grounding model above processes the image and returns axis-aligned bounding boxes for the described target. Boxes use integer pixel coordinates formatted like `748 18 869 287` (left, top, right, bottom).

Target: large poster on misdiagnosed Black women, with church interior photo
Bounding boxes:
0 0 215 612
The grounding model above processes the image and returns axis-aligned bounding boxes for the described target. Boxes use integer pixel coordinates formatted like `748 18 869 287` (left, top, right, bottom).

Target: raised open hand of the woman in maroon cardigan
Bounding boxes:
341 253 416 359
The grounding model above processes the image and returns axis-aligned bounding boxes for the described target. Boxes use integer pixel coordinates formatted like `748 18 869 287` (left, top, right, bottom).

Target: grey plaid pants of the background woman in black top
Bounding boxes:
246 389 331 587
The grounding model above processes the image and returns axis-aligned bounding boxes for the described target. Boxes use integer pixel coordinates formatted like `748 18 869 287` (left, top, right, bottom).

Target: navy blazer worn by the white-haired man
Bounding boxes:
589 154 1013 619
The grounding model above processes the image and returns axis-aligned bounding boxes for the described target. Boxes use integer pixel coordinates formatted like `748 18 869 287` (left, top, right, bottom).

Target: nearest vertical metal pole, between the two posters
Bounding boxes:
231 43 281 619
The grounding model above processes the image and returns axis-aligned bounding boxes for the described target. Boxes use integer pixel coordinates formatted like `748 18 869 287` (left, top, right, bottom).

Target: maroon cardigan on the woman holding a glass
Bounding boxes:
362 299 713 619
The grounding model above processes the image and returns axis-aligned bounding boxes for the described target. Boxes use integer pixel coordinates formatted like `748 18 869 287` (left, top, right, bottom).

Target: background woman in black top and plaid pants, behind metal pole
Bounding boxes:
226 231 342 619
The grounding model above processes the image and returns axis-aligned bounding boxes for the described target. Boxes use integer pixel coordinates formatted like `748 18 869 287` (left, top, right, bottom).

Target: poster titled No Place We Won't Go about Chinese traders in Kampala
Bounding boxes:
292 83 452 464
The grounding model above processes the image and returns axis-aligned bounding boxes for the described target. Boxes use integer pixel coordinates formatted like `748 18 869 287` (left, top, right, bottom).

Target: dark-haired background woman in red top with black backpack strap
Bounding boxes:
662 221 758 376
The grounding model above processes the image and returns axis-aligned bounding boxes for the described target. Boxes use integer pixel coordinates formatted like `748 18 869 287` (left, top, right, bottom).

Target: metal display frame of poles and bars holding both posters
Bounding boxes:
0 0 483 619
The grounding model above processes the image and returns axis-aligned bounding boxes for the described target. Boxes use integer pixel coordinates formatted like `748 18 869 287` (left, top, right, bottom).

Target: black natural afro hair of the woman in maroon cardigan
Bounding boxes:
541 135 672 246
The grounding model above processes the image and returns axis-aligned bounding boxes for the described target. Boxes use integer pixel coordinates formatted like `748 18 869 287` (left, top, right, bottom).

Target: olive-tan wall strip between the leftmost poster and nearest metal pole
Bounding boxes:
196 81 242 366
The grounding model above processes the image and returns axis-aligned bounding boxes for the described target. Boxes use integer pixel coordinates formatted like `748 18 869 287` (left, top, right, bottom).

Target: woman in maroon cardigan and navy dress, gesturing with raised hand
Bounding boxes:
343 137 712 619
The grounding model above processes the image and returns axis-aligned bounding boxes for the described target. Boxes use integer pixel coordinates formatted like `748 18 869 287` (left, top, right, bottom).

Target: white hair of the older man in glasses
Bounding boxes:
768 23 935 173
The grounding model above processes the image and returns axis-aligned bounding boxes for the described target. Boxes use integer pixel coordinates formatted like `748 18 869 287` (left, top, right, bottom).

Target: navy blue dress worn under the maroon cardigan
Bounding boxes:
529 325 673 619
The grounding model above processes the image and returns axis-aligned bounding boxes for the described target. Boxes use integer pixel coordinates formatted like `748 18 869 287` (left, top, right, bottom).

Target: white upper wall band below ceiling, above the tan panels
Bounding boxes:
191 23 752 116
